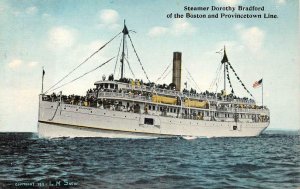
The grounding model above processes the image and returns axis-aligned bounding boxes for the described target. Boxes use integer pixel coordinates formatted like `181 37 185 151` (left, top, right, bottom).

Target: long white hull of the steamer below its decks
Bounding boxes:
38 97 269 138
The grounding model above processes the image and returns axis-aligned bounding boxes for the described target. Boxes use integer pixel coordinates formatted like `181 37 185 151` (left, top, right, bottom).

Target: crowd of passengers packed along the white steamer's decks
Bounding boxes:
43 75 266 111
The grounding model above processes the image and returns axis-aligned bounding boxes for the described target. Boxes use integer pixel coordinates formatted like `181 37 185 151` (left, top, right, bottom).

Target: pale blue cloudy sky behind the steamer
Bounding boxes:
0 0 300 132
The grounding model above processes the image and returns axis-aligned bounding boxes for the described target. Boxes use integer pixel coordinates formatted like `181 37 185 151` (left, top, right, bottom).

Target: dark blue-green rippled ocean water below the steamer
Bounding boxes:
0 133 300 188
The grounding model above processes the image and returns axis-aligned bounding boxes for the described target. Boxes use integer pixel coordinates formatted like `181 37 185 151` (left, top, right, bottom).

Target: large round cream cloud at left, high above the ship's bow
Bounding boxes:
48 26 76 51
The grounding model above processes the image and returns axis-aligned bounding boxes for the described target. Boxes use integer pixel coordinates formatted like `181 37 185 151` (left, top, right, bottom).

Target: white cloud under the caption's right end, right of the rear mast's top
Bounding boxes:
236 25 265 53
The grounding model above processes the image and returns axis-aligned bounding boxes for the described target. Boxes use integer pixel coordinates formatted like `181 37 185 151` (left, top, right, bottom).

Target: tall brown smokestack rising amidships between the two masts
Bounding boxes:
172 52 181 91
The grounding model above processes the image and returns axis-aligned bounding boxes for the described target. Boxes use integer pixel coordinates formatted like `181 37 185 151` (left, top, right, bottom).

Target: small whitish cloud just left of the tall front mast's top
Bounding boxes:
99 9 119 29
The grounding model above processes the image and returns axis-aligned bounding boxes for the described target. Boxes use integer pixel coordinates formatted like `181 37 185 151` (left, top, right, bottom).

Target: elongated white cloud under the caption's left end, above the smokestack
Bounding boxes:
148 19 196 37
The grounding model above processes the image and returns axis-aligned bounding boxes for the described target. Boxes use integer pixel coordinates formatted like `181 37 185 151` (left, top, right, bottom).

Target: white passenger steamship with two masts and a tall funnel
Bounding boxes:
38 22 270 138
